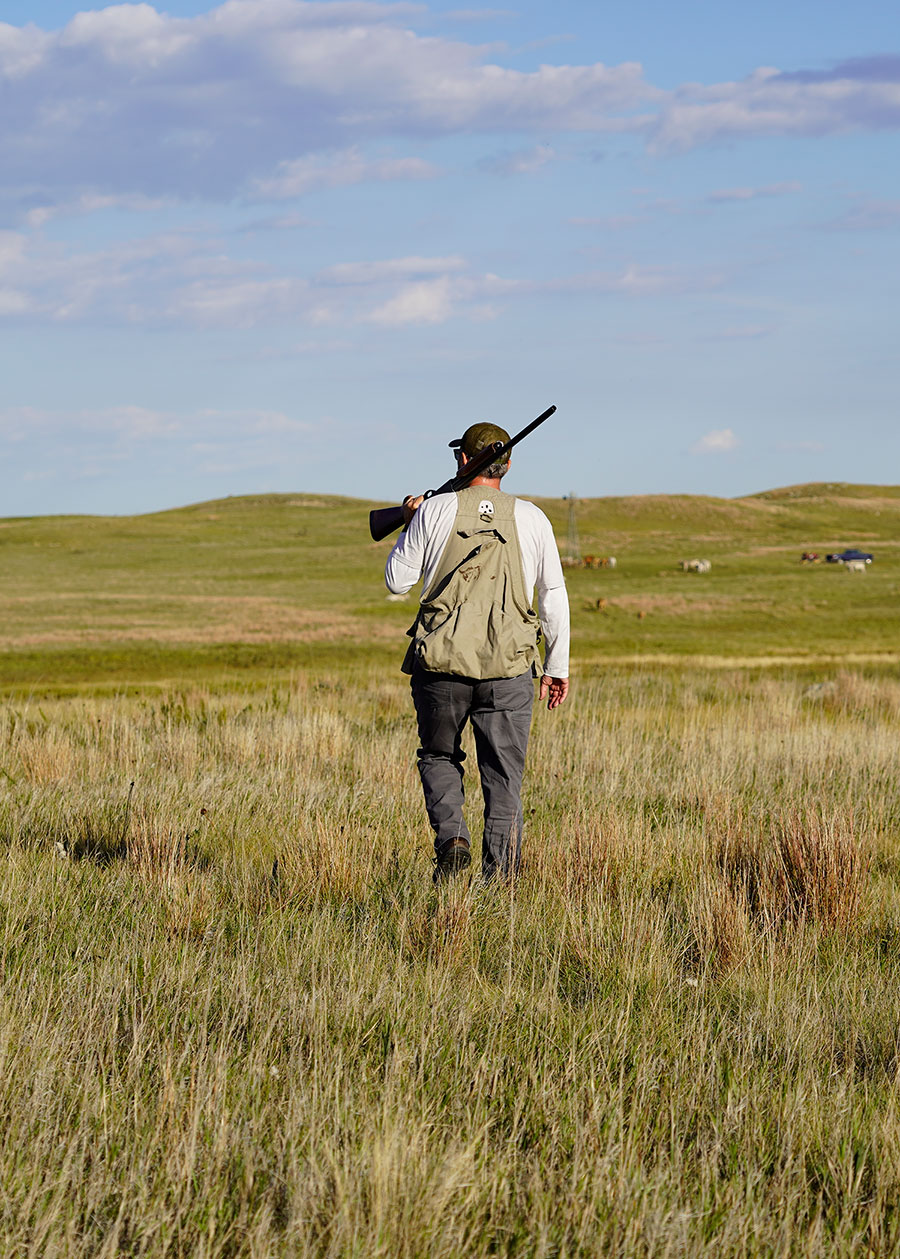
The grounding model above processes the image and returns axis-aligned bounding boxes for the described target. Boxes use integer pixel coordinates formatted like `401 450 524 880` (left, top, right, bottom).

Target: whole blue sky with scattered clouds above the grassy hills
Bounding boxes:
0 0 900 515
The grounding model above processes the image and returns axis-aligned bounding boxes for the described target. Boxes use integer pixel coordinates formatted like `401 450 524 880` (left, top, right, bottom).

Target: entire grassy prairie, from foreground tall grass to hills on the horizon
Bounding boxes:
0 486 900 1259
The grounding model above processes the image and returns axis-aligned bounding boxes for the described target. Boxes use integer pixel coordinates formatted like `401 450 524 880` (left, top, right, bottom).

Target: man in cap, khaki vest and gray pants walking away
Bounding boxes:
384 423 569 883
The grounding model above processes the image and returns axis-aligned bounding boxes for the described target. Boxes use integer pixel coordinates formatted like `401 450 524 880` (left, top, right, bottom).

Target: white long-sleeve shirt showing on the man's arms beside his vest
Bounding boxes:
384 494 569 677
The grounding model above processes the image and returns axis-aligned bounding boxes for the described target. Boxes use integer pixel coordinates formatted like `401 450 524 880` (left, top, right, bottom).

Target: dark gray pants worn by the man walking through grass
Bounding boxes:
412 666 534 879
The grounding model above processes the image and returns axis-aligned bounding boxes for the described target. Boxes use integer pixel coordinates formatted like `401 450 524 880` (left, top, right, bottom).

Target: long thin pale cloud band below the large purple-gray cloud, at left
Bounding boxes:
0 220 725 327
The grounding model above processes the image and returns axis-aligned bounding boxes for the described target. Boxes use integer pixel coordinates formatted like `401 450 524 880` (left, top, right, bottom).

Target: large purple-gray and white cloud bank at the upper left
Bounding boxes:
0 0 661 213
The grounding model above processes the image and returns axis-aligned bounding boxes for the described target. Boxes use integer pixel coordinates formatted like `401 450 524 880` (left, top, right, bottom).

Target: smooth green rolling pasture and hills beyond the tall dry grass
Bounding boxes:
0 485 900 692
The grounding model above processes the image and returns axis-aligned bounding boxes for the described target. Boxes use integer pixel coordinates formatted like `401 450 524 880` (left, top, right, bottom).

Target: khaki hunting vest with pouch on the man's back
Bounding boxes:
403 486 540 679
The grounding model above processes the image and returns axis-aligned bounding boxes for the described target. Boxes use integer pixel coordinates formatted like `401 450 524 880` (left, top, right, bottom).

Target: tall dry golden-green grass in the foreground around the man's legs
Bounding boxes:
0 674 900 1259
